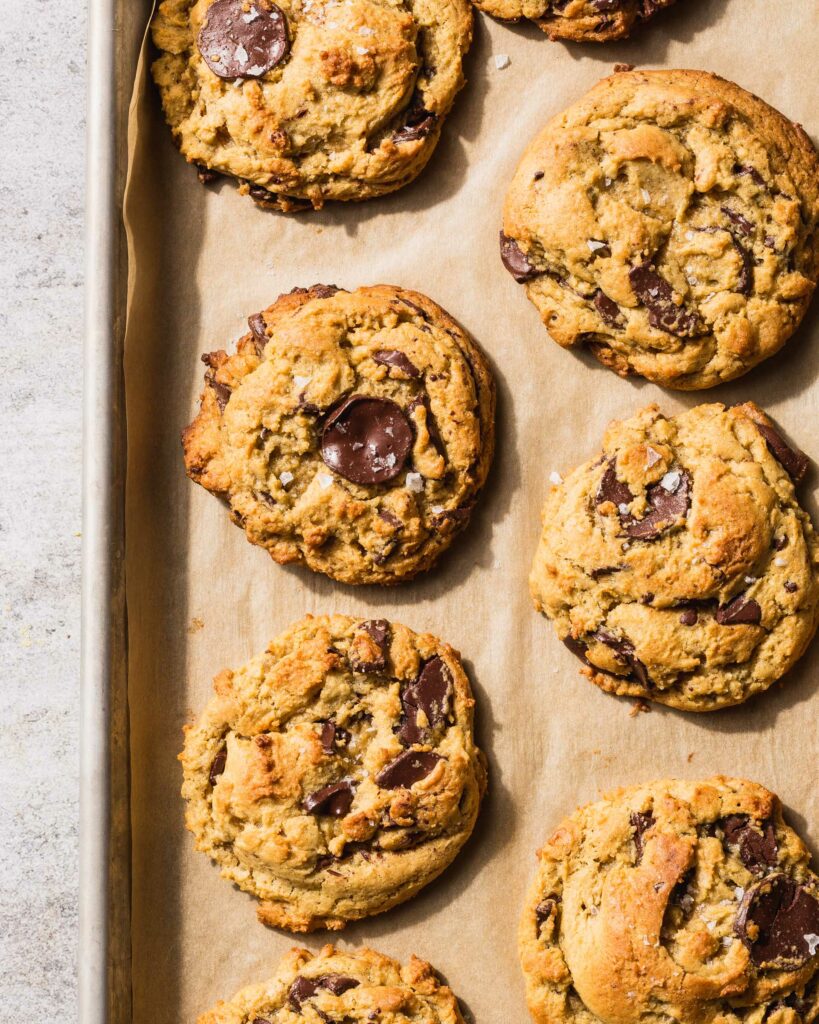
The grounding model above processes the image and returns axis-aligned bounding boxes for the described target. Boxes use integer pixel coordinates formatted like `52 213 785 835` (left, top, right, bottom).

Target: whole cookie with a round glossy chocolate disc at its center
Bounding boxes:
183 285 494 584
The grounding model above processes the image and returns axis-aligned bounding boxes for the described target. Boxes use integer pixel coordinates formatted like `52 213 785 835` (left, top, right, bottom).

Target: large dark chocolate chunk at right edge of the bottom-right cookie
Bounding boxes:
734 872 819 970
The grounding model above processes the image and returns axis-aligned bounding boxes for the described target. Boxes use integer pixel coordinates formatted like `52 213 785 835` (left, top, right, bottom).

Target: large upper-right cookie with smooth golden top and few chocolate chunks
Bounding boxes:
501 71 819 389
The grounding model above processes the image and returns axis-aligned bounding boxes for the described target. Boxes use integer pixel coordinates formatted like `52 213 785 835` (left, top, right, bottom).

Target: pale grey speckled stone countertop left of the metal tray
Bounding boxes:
0 0 86 1024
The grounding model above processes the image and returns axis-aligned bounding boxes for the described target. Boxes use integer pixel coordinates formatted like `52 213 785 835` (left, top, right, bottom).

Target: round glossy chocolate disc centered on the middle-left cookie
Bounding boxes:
321 394 413 483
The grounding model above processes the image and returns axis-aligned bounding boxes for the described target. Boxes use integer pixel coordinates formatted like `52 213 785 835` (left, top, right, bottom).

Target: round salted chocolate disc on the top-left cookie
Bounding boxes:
197 0 290 78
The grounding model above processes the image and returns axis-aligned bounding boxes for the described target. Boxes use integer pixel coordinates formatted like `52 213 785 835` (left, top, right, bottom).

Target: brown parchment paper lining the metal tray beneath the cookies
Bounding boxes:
125 0 819 1024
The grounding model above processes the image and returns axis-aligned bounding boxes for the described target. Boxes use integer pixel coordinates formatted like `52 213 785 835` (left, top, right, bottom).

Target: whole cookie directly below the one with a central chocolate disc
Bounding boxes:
180 615 486 932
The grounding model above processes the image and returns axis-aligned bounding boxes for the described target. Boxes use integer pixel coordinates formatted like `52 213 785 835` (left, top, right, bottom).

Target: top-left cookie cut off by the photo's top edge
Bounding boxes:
153 0 472 212
